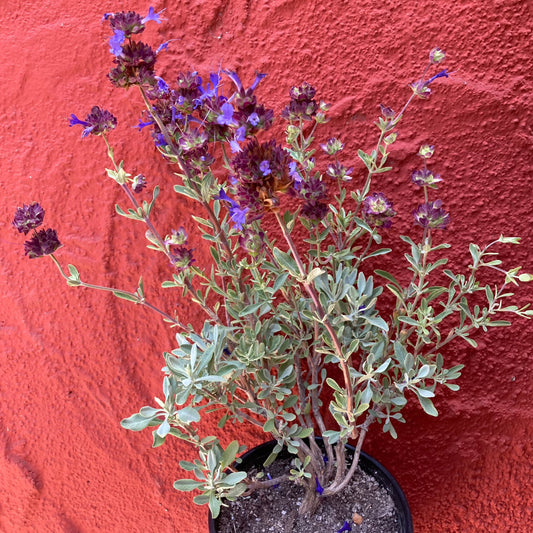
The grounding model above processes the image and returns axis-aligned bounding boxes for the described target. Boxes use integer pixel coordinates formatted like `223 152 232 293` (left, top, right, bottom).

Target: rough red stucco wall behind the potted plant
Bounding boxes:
0 0 533 533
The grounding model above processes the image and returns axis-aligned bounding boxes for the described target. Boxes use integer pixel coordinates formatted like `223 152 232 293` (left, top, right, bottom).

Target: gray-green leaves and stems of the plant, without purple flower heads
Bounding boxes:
53 46 532 517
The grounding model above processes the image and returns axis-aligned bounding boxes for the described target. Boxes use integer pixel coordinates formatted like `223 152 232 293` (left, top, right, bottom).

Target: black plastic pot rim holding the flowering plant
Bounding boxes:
208 438 413 533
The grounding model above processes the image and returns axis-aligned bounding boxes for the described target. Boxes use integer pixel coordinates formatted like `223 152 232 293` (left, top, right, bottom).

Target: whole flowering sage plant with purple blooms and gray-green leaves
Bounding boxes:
13 4 533 517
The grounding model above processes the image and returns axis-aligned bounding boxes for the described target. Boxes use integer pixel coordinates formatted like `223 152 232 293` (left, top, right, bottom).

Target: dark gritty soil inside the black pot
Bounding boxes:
212 454 399 533
